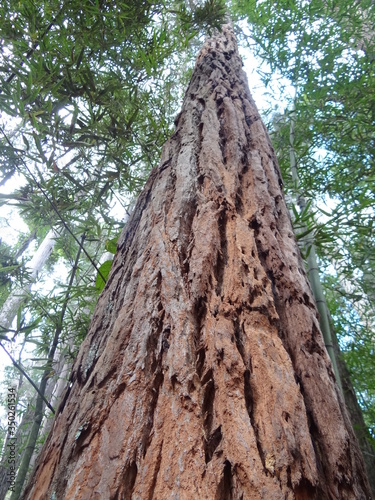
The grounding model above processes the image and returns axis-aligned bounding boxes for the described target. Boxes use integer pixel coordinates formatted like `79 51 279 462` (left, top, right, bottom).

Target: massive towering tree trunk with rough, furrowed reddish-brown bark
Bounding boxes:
25 28 370 500
